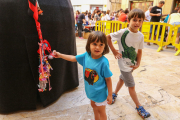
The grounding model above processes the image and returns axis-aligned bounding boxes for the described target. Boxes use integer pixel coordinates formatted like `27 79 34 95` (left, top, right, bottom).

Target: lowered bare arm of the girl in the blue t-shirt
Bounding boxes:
105 77 112 104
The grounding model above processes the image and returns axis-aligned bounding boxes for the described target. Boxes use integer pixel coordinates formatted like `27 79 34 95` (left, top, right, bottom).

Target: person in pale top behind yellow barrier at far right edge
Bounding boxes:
165 10 180 51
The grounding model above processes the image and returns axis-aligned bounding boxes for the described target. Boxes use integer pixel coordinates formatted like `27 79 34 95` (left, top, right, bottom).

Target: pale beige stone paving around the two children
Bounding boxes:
0 38 180 120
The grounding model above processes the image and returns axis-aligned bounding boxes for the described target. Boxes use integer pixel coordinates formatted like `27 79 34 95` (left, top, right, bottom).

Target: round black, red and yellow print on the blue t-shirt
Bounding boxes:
84 68 99 85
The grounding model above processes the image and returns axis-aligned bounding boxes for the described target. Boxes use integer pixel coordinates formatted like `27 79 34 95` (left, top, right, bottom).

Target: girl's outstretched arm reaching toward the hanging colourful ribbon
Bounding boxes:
53 50 77 62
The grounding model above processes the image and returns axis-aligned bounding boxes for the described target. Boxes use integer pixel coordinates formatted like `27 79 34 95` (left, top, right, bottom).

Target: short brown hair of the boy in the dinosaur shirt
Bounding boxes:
128 8 145 21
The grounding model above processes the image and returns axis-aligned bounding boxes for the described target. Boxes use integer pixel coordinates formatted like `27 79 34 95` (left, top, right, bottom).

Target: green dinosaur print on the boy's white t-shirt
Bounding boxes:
121 30 137 66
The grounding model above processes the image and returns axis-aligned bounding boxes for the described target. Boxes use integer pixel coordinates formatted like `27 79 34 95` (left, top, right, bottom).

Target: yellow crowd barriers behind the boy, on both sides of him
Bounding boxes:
95 21 180 55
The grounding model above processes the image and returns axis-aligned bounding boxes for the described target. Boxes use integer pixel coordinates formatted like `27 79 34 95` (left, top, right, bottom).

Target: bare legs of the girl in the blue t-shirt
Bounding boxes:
91 100 107 120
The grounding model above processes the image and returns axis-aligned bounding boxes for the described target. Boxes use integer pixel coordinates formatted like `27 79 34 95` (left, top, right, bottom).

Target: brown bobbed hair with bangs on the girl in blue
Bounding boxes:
86 31 109 55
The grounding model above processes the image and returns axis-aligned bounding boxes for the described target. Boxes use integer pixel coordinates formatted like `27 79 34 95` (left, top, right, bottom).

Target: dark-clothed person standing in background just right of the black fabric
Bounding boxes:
77 13 86 39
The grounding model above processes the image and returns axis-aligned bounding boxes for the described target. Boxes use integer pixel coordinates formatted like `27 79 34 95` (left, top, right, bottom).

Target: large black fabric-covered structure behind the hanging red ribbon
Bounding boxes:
0 0 79 113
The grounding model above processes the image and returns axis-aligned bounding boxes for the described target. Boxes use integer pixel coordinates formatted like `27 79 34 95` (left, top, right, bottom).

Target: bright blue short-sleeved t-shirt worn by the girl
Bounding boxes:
76 52 112 103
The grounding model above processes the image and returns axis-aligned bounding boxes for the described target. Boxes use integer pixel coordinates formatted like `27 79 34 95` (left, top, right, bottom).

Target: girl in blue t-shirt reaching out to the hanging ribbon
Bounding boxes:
53 31 112 120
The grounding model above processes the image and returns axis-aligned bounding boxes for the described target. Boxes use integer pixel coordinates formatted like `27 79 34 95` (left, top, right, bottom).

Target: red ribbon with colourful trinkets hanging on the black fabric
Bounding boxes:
28 0 54 92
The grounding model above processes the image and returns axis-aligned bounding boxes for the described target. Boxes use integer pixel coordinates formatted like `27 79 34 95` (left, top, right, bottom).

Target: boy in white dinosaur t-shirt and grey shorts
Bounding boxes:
107 9 150 118
